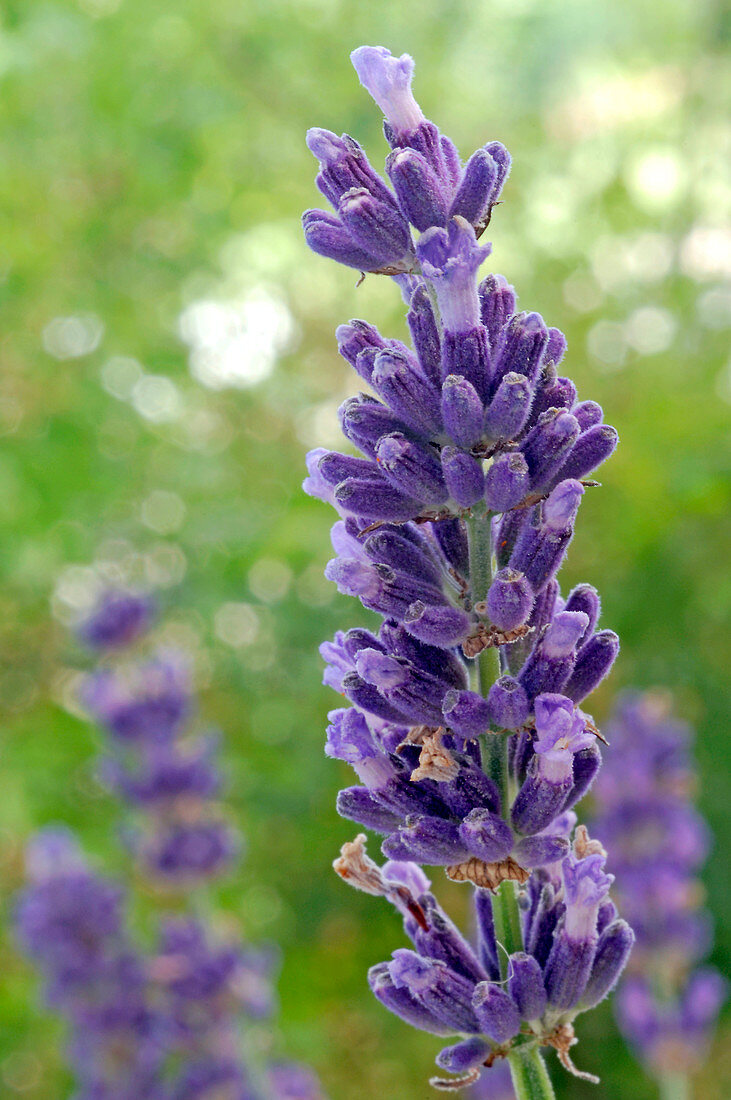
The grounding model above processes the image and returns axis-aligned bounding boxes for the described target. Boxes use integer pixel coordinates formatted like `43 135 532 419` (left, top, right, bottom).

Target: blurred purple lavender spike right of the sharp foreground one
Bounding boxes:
594 693 724 1078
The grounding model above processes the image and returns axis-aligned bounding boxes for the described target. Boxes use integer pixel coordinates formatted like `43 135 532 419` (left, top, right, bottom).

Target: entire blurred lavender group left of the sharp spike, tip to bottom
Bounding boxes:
16 593 322 1100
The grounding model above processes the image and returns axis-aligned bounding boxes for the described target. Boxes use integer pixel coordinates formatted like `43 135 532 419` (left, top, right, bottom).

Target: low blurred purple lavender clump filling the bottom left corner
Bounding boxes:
15 828 322 1100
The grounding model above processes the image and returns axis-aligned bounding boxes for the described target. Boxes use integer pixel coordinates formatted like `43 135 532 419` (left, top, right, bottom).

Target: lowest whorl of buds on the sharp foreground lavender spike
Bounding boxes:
334 831 633 1089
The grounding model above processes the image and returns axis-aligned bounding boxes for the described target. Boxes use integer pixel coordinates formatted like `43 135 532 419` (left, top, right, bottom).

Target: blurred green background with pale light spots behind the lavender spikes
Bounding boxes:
0 0 731 1100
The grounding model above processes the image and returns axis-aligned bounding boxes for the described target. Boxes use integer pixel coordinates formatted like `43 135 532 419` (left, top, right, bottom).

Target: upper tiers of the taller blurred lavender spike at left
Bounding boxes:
81 594 237 889
